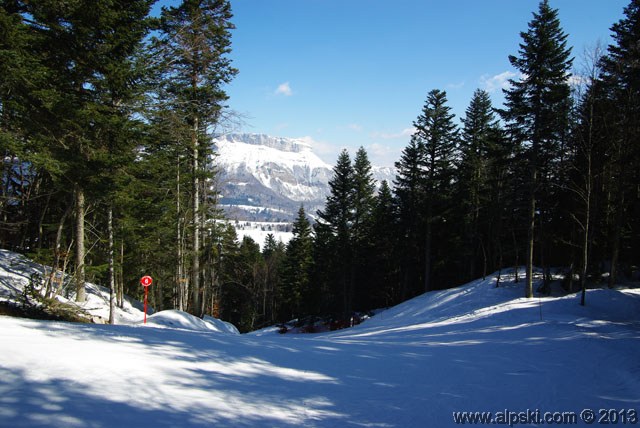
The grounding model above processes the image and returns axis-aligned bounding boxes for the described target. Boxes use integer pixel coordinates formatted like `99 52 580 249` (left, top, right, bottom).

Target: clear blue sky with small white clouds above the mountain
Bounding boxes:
160 0 629 166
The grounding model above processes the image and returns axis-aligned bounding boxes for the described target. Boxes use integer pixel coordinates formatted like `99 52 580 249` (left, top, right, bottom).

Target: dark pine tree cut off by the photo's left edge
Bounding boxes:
0 2 50 250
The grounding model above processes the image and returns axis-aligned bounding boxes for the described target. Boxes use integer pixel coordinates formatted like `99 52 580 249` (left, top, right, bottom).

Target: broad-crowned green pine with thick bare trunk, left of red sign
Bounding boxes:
8 0 157 301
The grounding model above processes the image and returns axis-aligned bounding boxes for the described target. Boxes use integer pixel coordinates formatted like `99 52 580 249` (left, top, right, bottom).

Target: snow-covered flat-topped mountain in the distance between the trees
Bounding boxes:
213 134 394 221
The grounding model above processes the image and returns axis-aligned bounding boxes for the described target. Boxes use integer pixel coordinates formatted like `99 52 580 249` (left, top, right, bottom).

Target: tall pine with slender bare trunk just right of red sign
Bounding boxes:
155 0 237 315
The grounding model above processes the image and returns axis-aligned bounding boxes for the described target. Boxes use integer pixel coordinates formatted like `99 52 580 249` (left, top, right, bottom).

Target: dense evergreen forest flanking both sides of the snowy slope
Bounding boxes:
0 0 640 331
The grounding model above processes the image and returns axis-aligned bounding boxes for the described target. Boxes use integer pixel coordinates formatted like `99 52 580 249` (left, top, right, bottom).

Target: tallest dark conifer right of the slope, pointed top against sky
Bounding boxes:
503 0 573 297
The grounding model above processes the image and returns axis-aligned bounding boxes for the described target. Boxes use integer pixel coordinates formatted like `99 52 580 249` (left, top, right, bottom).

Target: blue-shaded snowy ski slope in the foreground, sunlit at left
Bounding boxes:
0 249 640 427
